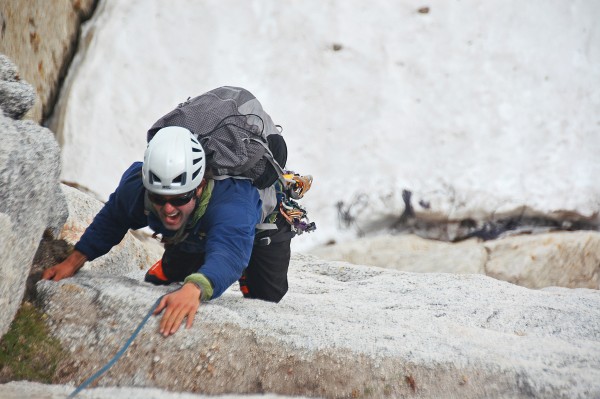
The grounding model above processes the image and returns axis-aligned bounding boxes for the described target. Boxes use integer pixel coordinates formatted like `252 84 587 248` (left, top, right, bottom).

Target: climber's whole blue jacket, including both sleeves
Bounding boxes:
75 162 262 298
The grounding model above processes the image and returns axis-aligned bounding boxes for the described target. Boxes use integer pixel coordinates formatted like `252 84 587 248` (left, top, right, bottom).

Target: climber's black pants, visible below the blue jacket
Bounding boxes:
145 215 293 302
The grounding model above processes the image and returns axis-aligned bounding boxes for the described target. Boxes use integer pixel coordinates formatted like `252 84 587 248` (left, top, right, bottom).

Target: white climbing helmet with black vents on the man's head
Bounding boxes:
142 126 206 195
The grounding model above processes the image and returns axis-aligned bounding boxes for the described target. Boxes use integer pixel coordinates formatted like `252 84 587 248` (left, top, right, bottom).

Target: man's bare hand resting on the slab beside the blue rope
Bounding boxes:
154 283 201 337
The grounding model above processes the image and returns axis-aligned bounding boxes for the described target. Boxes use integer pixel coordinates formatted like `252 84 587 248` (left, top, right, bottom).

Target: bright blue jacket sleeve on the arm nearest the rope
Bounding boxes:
198 179 261 299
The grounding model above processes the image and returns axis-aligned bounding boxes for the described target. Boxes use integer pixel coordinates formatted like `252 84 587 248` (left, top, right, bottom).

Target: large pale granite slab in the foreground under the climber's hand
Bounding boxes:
37 254 600 398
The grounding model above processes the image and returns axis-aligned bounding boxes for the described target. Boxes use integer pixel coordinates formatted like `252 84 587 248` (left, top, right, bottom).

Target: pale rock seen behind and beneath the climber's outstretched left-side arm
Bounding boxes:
58 184 163 275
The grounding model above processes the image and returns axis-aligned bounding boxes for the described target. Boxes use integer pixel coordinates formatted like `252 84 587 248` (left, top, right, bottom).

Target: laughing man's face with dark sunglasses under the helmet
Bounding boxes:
148 188 202 231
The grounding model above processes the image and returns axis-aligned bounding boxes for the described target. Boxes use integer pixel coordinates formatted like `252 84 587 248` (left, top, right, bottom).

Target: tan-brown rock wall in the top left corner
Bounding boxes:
0 0 96 122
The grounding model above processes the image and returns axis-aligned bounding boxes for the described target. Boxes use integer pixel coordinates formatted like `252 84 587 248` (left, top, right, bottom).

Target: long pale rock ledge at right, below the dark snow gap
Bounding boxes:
310 231 600 289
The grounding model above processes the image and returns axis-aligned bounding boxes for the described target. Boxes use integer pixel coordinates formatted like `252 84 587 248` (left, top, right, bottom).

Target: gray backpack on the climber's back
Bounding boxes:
147 86 287 189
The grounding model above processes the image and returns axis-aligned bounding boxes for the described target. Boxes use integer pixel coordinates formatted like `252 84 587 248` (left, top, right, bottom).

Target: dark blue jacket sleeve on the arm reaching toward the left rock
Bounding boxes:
75 162 148 261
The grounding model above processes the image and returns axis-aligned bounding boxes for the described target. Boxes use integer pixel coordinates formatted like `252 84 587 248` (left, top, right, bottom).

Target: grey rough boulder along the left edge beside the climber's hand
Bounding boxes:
0 58 67 337
